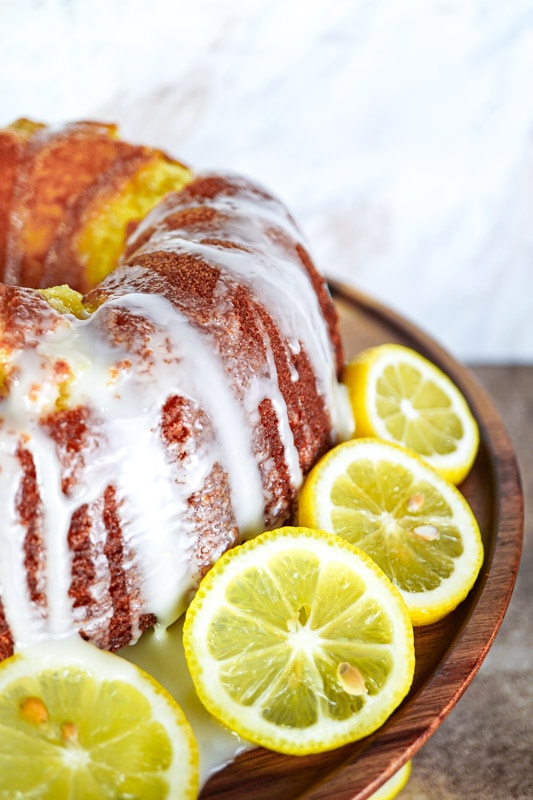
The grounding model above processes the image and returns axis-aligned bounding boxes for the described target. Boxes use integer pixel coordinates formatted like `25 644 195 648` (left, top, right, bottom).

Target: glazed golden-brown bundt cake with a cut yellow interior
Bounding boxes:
0 120 350 658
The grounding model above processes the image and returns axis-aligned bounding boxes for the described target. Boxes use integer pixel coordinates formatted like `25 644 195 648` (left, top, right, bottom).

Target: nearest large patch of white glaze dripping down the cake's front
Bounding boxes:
1 276 320 644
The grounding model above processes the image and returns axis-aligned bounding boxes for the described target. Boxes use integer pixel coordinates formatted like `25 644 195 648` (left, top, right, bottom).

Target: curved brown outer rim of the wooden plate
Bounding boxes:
201 280 523 800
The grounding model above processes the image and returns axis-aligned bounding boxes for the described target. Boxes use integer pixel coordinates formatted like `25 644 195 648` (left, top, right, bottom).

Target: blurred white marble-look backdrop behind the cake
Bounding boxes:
0 0 533 362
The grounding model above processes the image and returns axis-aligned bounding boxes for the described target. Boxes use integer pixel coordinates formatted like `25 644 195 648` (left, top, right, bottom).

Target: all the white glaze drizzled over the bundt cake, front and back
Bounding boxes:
0 175 351 656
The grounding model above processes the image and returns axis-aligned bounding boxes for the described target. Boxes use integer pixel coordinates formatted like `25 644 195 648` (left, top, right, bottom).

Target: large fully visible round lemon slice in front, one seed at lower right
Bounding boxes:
184 527 414 755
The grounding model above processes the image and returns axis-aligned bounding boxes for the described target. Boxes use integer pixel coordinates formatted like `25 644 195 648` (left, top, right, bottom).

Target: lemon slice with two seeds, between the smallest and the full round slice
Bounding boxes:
298 439 483 625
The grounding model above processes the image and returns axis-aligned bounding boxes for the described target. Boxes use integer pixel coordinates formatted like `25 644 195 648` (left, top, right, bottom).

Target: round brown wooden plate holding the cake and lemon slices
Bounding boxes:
197 283 523 800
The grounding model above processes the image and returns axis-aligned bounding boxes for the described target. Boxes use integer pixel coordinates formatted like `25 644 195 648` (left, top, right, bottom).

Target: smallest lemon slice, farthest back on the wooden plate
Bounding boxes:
343 344 479 484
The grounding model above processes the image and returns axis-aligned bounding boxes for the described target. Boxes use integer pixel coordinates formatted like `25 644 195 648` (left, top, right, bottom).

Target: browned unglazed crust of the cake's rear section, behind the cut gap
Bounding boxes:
0 121 190 292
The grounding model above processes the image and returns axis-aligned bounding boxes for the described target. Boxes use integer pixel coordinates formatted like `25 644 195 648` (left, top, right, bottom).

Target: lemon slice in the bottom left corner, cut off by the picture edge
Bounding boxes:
0 640 198 800
